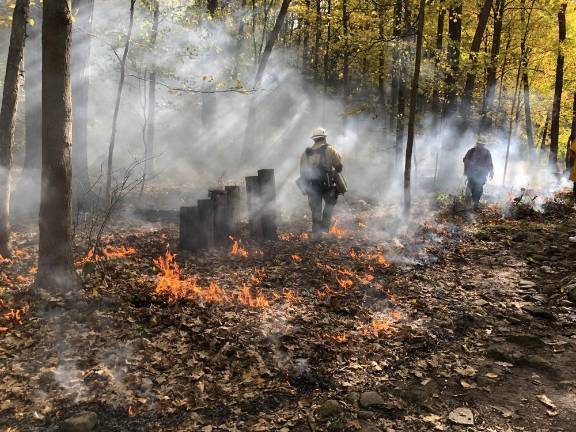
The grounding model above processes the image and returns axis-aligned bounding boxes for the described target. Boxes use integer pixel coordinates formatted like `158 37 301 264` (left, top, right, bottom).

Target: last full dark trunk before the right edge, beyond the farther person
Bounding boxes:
549 3 568 171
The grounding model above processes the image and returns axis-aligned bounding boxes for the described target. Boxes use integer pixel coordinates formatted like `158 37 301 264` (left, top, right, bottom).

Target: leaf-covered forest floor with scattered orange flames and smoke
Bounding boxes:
0 191 576 432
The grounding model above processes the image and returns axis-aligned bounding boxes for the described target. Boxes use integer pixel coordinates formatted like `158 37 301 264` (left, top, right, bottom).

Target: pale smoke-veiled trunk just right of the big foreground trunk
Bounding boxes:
72 0 94 206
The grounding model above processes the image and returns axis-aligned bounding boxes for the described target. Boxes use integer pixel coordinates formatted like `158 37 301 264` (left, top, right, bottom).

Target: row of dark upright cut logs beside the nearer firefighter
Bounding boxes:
180 169 277 251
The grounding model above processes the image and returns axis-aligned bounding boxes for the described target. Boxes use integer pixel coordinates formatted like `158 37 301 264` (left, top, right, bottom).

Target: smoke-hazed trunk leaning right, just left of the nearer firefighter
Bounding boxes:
241 0 291 163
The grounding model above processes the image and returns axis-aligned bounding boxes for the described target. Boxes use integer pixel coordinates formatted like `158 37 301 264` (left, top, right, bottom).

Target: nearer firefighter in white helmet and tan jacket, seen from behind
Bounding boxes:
300 128 343 233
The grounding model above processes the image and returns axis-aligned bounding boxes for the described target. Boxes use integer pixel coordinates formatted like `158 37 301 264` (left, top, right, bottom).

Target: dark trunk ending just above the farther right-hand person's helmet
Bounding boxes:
481 0 506 132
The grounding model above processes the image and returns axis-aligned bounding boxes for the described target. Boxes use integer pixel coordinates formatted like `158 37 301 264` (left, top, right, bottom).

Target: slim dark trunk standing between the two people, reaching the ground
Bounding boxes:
404 0 426 215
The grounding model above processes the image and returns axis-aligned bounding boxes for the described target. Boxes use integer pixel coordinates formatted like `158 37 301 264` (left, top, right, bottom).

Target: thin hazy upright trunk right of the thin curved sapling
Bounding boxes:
142 0 160 188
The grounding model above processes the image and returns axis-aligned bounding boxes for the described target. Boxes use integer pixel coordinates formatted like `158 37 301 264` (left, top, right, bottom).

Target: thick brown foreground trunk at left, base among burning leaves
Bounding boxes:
36 0 79 292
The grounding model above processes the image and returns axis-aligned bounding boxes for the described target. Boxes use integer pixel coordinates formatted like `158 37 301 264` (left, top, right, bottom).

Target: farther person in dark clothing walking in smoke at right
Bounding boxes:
464 138 494 209
